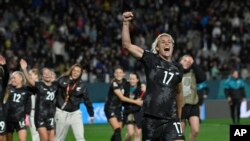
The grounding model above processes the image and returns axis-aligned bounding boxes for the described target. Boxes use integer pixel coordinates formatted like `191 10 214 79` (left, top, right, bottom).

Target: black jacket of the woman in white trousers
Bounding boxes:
56 76 94 117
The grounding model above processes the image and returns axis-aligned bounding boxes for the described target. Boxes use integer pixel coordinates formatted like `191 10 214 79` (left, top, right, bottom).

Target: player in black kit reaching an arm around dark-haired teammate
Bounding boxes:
104 67 142 141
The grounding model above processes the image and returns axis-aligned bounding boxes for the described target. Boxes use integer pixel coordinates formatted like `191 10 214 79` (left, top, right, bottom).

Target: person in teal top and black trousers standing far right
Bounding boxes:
224 70 246 124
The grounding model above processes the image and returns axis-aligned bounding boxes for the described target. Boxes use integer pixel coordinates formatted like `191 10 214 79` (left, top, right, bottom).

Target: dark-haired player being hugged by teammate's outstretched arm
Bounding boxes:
123 72 145 141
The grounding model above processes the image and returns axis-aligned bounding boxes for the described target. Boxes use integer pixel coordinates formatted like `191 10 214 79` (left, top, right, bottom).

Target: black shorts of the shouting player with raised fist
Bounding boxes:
142 115 185 141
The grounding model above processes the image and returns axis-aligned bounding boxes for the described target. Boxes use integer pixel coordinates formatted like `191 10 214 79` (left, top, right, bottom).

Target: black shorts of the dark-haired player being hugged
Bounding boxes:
123 111 142 128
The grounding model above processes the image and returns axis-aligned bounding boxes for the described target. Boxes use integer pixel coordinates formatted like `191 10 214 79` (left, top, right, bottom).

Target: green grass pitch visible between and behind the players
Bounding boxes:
14 119 250 141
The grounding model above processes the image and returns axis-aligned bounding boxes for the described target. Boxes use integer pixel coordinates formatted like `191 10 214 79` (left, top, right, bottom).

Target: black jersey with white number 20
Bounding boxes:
35 81 58 118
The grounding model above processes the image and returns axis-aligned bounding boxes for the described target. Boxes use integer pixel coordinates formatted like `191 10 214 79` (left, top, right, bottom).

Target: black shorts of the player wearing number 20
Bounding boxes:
35 117 55 130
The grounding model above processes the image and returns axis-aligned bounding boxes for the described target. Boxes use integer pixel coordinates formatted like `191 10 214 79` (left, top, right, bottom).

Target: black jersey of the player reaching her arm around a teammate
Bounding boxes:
104 79 127 110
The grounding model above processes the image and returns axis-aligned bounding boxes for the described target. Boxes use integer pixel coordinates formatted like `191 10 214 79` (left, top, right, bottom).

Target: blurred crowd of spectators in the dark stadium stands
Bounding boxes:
0 0 250 82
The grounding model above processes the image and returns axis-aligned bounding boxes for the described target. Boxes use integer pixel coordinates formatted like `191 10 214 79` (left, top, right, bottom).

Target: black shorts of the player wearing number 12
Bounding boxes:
6 118 26 133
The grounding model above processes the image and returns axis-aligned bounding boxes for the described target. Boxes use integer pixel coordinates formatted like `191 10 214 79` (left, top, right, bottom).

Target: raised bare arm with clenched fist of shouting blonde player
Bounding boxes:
122 12 143 58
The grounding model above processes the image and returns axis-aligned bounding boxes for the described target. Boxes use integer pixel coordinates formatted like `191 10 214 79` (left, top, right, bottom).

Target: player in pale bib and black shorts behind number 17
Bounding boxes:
180 55 206 141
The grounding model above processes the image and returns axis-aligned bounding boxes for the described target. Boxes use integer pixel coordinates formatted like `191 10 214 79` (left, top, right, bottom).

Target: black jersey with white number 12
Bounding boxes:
7 85 31 122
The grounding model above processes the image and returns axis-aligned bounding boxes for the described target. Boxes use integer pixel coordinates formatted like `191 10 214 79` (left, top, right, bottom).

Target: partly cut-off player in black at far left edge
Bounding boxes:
0 55 9 141
